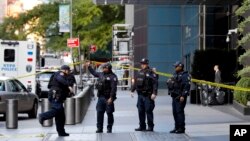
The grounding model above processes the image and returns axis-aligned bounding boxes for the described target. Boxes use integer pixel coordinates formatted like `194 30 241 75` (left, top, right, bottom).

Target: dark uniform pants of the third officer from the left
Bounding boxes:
137 93 155 129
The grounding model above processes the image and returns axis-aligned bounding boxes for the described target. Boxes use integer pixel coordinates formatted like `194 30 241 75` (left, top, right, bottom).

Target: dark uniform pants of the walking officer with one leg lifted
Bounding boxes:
41 100 65 134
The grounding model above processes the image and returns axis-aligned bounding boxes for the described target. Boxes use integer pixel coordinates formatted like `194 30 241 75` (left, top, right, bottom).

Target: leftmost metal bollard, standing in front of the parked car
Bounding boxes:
6 99 18 129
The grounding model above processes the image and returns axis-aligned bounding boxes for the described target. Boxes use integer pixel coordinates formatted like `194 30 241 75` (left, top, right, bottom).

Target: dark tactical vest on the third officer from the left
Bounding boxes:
136 69 153 94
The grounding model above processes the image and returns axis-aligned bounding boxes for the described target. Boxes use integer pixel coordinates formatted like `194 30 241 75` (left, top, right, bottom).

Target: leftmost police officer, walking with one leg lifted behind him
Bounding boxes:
39 65 73 136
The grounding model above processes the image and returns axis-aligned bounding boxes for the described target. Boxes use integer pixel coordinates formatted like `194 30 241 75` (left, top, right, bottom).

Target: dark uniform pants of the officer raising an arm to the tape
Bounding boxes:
96 96 115 129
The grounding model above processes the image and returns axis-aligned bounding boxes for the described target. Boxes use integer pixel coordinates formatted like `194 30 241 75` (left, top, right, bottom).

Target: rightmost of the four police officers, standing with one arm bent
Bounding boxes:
167 61 191 134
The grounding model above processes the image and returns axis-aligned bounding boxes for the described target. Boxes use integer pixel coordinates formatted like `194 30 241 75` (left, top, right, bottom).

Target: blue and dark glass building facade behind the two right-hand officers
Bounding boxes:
134 5 232 87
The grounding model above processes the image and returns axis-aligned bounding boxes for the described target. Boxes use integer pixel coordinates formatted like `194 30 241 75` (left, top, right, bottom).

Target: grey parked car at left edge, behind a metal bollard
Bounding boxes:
0 76 39 118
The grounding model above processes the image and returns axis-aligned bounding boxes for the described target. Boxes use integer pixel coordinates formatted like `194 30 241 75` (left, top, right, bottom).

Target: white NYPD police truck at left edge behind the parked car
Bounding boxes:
0 39 37 93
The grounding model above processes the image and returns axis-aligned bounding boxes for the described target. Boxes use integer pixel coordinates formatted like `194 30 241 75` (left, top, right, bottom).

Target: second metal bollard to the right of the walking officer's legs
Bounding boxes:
75 97 83 123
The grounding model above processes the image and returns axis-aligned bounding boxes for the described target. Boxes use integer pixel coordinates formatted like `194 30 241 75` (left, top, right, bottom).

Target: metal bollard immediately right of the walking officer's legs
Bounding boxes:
64 98 75 125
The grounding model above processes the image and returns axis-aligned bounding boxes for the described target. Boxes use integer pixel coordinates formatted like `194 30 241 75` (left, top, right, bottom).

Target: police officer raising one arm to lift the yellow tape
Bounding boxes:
86 62 117 133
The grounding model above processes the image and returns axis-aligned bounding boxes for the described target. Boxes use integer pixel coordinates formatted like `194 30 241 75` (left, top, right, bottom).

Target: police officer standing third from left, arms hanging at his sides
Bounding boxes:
131 58 158 131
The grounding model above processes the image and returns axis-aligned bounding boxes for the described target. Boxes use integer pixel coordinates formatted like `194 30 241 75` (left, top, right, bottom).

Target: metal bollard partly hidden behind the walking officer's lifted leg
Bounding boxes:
41 98 53 127
